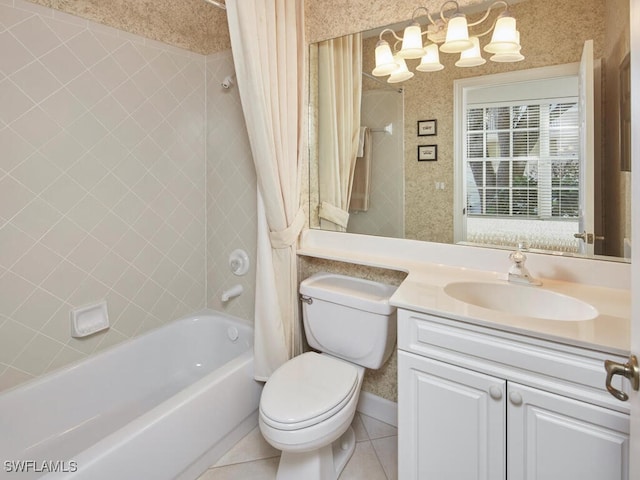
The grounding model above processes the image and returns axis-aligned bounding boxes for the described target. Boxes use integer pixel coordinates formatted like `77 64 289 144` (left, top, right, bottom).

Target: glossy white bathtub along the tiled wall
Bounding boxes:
0 311 262 480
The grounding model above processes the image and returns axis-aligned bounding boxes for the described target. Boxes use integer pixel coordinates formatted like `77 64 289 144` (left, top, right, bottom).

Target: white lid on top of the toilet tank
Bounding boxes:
300 272 397 315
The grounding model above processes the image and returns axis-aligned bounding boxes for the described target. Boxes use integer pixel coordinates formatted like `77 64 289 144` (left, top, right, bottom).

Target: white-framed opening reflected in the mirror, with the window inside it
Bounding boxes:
454 69 585 252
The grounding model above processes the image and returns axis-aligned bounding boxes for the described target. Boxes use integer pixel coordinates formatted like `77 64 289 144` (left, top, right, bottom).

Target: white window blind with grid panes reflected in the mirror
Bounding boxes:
464 101 580 220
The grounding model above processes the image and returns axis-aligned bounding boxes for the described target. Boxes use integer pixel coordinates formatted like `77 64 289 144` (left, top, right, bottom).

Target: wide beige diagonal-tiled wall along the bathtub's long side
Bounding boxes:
0 0 215 389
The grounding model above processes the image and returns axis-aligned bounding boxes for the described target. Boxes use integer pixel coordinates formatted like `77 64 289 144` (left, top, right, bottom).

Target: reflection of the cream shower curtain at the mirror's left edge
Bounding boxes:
318 34 362 231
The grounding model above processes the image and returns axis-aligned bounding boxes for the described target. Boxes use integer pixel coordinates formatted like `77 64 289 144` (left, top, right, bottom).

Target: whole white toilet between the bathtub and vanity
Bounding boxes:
259 273 396 480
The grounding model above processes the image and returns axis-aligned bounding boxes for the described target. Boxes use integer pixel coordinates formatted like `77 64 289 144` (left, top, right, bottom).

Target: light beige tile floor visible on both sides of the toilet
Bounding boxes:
198 413 398 480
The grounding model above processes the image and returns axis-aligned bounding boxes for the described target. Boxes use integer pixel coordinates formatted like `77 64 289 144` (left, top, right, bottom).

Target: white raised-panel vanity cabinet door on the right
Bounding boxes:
507 382 629 480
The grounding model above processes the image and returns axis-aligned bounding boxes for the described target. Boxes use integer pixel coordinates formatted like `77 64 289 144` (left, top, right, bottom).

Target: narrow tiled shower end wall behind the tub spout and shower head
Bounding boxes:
207 51 257 319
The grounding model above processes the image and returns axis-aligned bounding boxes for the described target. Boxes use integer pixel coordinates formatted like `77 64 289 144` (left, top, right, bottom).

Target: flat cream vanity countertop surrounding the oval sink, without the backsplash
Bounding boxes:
390 265 631 356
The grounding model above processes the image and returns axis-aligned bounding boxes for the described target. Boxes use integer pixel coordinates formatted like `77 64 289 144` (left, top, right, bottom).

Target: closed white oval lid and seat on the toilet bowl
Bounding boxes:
260 352 358 430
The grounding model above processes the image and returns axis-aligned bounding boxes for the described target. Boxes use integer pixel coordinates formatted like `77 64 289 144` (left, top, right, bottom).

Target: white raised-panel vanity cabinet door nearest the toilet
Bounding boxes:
398 351 506 480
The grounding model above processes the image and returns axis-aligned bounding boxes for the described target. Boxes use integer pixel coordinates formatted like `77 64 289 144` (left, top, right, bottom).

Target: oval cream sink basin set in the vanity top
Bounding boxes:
444 282 598 321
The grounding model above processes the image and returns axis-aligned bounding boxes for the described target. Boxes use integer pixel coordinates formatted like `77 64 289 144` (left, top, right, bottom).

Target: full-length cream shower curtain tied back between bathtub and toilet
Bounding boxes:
226 0 305 380
